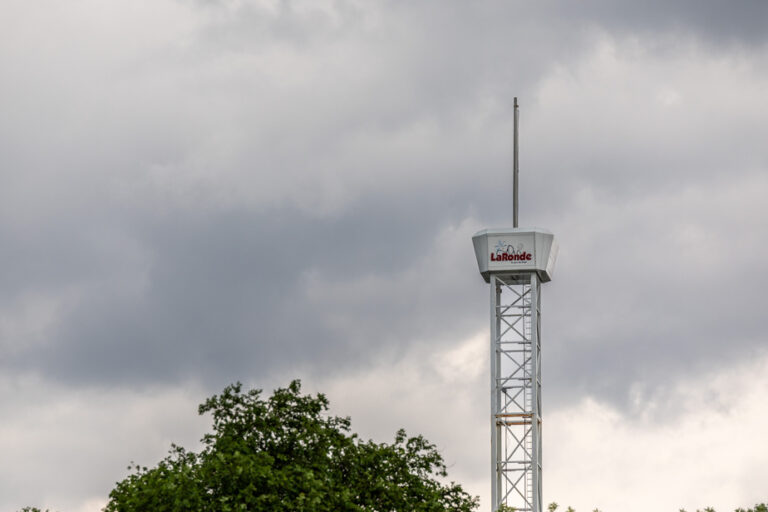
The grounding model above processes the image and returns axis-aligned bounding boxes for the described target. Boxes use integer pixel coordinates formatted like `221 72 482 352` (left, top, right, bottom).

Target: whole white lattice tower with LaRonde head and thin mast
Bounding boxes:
472 98 558 512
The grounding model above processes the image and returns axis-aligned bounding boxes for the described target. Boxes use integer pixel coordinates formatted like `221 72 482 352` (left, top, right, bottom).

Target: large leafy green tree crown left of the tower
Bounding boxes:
104 381 477 512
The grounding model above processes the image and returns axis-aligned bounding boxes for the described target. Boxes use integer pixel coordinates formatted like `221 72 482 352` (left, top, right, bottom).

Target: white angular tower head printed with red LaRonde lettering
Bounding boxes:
472 228 558 282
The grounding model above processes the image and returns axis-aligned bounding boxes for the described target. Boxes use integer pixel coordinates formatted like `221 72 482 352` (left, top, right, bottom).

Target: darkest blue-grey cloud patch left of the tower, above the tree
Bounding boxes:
6 198 478 384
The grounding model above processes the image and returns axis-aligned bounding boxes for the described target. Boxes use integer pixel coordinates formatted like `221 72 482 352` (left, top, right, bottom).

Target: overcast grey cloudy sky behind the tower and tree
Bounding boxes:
0 0 768 512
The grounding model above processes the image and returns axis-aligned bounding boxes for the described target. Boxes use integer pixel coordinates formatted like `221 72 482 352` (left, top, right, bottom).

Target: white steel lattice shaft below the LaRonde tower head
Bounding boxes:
490 272 542 512
